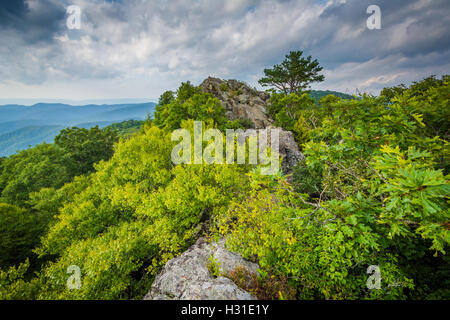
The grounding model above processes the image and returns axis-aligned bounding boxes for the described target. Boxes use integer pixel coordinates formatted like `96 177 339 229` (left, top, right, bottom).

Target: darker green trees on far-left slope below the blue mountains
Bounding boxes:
0 127 116 271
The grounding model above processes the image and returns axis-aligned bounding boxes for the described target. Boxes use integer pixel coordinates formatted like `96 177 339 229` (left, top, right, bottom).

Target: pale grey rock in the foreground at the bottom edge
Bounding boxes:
144 238 258 300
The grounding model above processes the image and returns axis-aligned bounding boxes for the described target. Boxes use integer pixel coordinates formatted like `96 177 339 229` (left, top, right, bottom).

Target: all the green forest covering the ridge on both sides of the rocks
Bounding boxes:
0 76 450 299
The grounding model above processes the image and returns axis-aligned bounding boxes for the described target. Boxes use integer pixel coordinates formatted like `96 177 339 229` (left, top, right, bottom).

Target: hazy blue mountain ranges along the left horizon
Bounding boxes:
0 102 156 156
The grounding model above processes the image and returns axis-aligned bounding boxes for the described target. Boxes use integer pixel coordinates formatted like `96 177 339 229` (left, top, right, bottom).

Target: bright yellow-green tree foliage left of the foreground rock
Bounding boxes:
22 125 251 299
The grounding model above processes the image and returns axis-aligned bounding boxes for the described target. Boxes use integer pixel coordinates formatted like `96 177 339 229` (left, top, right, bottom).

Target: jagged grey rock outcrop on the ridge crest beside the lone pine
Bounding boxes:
200 77 304 174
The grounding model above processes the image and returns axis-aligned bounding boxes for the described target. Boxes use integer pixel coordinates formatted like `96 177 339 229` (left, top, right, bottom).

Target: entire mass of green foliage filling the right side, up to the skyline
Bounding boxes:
217 77 450 299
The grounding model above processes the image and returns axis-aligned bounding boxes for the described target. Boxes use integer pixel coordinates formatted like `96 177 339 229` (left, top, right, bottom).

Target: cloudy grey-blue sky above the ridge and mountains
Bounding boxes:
0 0 450 104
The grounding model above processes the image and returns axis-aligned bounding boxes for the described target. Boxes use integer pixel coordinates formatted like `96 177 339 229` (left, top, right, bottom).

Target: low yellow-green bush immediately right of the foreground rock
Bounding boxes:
220 171 418 299
